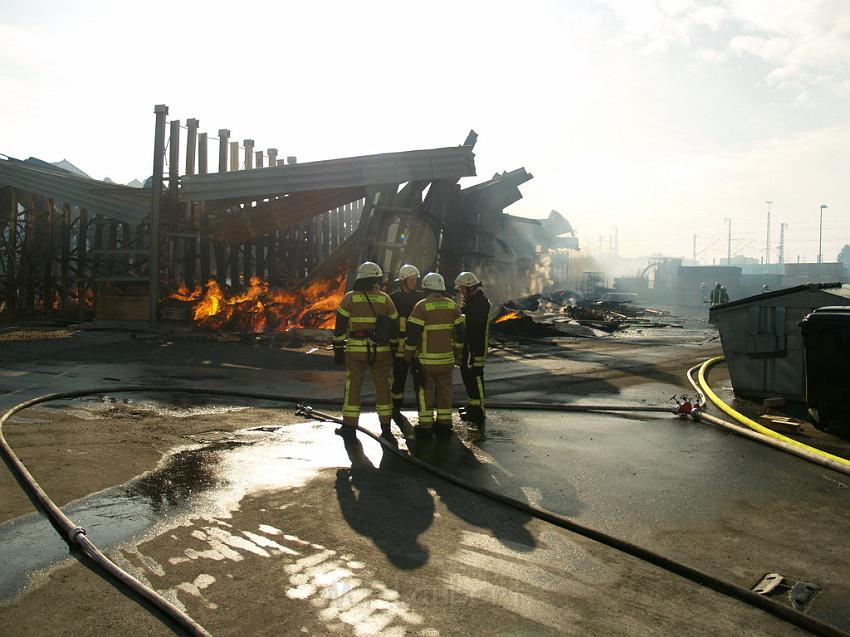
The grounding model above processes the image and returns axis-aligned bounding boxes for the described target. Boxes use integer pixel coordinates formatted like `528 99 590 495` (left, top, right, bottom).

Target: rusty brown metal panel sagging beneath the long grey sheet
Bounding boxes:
210 188 366 245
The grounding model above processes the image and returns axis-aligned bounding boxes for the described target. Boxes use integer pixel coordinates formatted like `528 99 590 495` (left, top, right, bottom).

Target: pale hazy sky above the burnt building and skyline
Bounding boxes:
0 0 850 263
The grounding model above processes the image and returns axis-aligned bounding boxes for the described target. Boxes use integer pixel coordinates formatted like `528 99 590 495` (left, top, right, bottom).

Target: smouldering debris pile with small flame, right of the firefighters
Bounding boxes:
492 290 674 336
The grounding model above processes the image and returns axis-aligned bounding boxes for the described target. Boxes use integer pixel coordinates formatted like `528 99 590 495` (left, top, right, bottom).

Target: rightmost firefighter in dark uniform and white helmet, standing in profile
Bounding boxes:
455 272 490 424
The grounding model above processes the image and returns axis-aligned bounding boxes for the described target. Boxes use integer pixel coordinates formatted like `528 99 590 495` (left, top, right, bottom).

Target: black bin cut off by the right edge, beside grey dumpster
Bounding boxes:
800 306 850 428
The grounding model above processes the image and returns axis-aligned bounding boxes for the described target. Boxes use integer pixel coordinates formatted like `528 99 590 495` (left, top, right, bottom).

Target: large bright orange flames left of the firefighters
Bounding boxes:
185 271 345 333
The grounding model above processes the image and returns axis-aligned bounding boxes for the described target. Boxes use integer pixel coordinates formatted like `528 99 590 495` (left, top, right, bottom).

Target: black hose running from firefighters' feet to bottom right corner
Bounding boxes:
297 405 850 637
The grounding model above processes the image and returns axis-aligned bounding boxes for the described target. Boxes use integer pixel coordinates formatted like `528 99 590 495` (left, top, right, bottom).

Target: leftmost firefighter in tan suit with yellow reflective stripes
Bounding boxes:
333 261 398 437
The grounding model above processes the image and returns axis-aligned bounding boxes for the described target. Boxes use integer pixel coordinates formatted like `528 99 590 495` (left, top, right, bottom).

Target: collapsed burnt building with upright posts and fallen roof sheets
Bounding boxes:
0 105 576 322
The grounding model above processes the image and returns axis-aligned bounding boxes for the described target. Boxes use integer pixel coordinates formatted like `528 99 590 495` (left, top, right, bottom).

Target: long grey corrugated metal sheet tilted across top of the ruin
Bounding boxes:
180 146 475 201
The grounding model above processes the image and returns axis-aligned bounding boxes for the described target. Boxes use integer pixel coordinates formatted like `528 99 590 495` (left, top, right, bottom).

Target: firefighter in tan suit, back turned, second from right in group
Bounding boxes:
404 272 464 438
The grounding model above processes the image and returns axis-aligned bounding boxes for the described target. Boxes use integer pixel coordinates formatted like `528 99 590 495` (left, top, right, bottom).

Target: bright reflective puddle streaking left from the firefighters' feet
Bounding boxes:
0 422 381 600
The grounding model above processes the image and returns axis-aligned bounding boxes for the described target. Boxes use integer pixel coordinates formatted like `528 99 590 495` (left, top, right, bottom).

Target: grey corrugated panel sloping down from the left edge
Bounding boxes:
0 159 151 224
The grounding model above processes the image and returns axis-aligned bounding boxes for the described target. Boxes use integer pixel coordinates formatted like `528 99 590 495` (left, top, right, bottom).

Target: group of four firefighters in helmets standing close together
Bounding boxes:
333 261 490 439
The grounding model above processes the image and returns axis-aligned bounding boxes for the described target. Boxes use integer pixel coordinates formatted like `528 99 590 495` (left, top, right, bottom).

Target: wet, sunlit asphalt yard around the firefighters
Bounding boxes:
0 320 850 635
